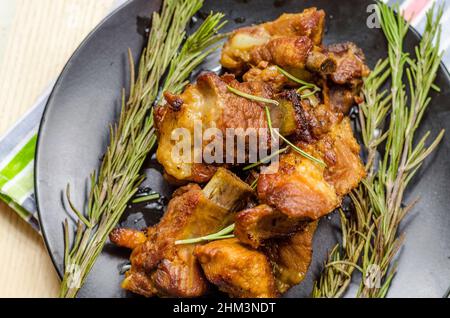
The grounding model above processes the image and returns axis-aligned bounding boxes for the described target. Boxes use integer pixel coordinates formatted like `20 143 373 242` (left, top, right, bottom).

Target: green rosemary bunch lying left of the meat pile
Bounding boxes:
60 0 225 298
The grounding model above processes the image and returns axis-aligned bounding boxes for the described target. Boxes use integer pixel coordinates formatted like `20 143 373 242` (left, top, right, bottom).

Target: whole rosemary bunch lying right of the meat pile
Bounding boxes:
313 3 443 297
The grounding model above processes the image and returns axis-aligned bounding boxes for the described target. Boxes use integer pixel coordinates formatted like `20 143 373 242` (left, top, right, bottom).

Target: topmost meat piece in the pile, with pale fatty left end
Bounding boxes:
221 8 325 74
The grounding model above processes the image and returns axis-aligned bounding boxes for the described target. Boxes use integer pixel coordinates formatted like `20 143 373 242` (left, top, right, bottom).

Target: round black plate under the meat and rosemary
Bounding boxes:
36 0 450 297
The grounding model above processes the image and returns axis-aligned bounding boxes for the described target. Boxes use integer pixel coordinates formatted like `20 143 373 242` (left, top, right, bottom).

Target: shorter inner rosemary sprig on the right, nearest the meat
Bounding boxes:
312 60 390 298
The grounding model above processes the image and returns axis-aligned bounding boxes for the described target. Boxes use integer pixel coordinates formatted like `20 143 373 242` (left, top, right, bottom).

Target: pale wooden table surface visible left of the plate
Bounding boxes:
0 0 115 297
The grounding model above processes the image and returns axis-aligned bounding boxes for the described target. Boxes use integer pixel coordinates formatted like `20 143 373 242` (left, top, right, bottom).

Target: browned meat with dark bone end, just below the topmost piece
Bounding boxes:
243 38 370 97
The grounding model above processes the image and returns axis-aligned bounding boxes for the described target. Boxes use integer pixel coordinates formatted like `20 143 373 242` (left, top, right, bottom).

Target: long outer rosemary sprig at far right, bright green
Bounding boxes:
359 3 444 297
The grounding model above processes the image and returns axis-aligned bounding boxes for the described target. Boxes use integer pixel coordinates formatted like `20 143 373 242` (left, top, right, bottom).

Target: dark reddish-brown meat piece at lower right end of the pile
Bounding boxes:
263 222 317 294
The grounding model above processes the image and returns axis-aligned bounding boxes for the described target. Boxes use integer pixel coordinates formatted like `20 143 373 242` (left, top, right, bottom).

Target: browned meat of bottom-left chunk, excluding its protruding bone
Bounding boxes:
122 185 215 297
